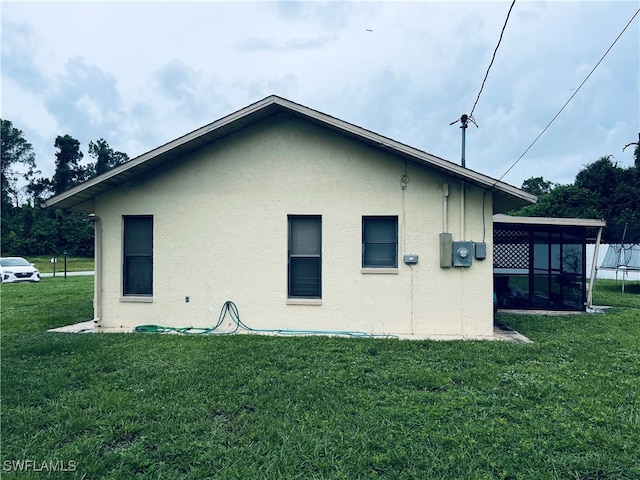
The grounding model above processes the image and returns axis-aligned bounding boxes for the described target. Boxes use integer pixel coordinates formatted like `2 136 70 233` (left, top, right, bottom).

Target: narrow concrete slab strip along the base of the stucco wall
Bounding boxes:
48 320 531 343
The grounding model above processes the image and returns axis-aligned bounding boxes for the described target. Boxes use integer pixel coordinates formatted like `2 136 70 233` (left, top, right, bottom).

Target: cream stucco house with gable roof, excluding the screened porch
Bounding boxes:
44 96 536 338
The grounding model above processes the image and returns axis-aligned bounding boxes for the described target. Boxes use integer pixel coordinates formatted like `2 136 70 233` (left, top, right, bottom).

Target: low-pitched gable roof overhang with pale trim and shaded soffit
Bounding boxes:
42 95 537 212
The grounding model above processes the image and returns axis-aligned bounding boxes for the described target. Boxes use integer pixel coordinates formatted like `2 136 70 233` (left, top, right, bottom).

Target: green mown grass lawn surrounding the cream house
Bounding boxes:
0 277 640 480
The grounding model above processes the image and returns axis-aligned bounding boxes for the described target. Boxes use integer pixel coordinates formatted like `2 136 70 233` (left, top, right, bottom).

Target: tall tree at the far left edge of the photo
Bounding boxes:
0 119 37 212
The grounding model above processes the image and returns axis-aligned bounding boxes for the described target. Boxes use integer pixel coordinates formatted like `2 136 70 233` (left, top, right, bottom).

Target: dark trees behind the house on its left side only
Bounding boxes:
0 119 129 257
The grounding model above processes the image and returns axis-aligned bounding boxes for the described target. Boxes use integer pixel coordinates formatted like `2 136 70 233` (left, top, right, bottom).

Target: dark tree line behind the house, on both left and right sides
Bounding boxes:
0 119 640 257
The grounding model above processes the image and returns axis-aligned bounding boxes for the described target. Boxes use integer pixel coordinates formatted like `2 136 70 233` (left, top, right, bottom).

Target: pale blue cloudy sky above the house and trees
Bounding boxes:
0 0 640 191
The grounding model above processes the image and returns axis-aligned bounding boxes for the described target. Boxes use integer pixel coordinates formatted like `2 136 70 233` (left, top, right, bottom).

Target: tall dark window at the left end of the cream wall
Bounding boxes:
123 216 153 296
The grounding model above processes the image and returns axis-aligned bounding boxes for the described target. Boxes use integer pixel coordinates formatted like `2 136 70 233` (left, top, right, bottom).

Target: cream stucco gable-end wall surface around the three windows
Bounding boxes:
96 114 493 338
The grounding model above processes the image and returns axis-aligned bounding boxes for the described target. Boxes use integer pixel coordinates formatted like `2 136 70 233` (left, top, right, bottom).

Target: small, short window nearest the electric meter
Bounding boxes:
362 217 398 267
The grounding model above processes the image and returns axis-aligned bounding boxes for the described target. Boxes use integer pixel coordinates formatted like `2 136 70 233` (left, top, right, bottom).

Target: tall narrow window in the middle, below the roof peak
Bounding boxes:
288 216 322 298
